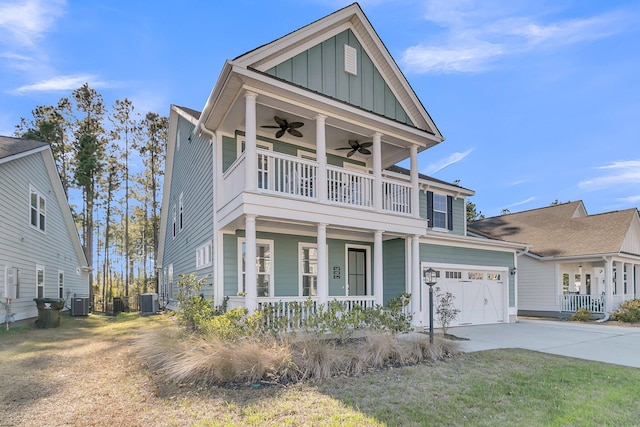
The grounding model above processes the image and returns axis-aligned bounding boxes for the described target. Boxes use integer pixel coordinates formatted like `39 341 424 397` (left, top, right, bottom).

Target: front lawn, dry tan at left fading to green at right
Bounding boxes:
0 315 640 427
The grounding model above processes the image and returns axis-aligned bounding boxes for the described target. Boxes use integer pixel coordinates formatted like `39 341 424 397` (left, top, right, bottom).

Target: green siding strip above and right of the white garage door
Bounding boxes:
420 243 516 307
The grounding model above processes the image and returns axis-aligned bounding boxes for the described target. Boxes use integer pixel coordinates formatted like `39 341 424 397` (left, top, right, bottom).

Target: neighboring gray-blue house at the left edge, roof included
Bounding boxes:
0 136 89 322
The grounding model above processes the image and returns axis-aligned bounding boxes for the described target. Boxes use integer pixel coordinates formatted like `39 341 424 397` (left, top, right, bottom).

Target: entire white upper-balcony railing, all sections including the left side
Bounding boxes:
220 149 413 215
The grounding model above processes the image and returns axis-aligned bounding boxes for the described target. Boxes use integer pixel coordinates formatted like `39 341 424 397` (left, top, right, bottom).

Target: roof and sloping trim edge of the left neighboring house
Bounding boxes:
0 135 90 269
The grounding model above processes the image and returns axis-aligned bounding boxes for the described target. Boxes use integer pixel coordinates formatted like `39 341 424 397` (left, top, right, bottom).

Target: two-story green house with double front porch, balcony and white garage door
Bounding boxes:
158 3 524 326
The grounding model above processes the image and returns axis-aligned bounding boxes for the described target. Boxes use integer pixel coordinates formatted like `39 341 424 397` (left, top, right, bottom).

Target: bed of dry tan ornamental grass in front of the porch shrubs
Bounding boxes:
139 327 459 386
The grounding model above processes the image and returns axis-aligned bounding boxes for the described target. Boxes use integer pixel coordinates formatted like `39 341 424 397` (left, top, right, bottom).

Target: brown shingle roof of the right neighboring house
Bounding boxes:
468 201 638 258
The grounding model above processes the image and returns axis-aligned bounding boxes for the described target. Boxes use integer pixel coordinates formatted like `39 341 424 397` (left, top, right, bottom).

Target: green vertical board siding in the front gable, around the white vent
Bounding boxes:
267 30 413 125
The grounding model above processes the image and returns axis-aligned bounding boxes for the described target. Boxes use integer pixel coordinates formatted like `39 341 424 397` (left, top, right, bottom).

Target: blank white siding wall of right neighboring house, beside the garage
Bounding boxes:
518 255 560 311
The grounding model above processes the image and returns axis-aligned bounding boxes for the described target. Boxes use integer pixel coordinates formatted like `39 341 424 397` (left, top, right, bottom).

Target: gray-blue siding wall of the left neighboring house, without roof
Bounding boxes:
0 150 89 321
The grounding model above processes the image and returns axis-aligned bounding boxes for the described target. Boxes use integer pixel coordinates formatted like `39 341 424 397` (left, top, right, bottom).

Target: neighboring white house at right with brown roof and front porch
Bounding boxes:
469 201 640 316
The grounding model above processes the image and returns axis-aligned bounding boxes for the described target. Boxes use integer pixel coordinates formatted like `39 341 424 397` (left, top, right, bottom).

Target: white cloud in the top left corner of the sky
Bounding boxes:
0 0 66 48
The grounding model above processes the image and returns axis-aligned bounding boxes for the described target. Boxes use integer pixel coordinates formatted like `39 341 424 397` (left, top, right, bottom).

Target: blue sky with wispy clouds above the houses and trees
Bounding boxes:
0 0 640 216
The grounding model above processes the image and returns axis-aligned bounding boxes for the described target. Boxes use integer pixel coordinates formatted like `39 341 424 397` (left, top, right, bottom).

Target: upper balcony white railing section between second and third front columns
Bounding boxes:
327 166 373 208
